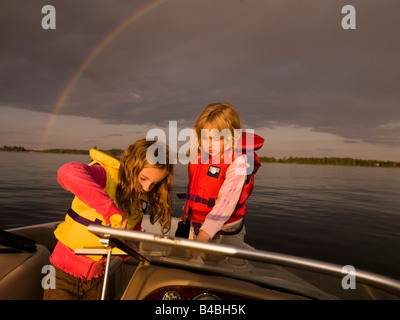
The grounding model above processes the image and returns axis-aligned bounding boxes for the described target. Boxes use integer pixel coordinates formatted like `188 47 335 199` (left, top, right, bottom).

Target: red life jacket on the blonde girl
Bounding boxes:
183 133 264 230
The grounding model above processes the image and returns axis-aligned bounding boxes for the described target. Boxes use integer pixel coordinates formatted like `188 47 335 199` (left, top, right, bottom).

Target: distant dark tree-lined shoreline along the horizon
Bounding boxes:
0 145 400 168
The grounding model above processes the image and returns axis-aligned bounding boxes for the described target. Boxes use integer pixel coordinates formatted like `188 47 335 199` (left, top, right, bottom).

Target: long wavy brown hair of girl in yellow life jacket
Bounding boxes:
116 139 173 233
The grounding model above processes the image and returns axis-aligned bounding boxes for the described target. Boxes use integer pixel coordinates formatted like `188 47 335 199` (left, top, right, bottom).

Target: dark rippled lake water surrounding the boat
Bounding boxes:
0 152 400 279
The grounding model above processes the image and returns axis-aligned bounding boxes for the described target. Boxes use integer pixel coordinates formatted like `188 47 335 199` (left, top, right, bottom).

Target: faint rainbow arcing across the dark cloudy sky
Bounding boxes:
41 0 166 149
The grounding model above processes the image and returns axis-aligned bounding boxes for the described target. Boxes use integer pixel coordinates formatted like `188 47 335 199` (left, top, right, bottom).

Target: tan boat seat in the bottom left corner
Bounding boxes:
0 244 50 300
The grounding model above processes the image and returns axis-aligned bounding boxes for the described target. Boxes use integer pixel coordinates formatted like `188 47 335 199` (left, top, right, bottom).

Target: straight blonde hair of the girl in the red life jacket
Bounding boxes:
190 102 242 161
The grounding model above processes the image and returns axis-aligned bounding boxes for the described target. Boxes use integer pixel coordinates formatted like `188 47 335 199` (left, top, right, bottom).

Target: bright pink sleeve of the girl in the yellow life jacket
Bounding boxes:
57 162 123 224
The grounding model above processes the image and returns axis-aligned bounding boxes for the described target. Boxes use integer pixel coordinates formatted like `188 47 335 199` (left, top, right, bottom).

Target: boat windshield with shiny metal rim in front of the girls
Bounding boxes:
88 225 400 300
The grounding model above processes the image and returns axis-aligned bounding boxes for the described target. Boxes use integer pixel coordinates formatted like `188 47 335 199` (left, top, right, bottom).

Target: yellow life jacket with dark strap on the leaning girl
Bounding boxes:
54 149 148 261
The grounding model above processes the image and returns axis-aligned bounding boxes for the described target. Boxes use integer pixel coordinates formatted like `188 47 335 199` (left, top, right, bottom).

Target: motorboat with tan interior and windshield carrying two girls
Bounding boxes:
0 215 400 301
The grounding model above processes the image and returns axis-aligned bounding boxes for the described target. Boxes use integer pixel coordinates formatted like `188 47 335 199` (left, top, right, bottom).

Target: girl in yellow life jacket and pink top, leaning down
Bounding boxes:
44 139 173 299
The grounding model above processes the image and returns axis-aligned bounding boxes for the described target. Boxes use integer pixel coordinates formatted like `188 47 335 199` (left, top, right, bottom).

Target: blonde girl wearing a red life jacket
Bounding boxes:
181 103 264 246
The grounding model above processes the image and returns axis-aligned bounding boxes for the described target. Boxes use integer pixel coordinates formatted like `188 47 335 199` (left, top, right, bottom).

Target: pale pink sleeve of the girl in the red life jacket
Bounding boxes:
201 155 247 238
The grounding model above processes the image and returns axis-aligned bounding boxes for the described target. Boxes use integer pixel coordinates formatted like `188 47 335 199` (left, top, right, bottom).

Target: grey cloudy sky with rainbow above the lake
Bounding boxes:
0 0 400 161
